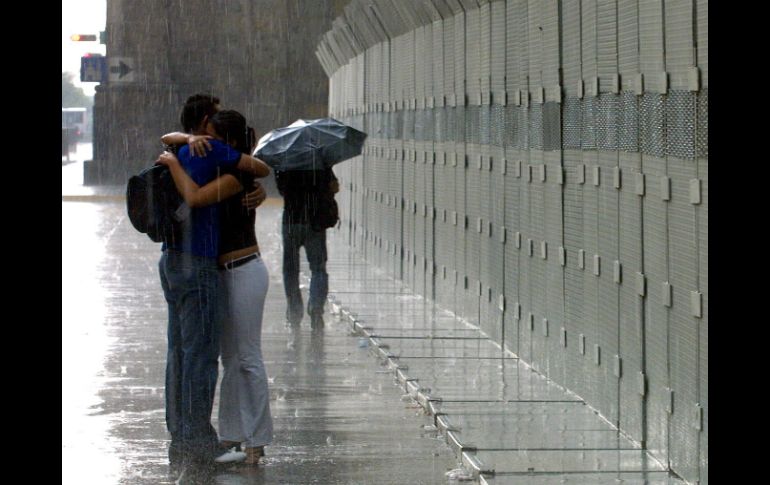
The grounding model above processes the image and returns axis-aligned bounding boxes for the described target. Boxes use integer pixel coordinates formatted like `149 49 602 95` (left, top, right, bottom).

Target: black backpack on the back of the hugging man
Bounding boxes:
126 165 190 245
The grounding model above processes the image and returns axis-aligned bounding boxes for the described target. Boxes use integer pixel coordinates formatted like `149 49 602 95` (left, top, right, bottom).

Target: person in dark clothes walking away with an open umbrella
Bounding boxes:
255 118 366 329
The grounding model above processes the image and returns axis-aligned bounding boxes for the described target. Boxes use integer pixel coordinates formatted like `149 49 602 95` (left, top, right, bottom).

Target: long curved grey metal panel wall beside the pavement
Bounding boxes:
316 0 708 483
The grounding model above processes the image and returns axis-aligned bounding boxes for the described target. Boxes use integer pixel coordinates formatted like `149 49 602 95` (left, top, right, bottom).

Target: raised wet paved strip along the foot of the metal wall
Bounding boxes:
328 244 684 485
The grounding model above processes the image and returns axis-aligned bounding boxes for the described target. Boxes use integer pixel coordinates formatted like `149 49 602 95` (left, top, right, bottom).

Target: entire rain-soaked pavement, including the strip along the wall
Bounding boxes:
62 154 682 485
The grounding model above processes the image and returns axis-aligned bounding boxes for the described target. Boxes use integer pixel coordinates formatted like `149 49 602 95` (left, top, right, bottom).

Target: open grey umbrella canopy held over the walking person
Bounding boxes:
254 118 366 172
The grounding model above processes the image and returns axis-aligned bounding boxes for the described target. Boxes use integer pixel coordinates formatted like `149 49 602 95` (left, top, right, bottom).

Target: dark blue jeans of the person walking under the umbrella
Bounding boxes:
281 222 329 323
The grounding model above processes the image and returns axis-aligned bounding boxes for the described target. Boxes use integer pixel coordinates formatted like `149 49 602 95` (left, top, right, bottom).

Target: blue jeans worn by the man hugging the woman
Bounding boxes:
159 250 221 461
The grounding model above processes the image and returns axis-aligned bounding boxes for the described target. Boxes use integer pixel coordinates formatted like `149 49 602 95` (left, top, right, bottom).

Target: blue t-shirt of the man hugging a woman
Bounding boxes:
164 140 242 258
